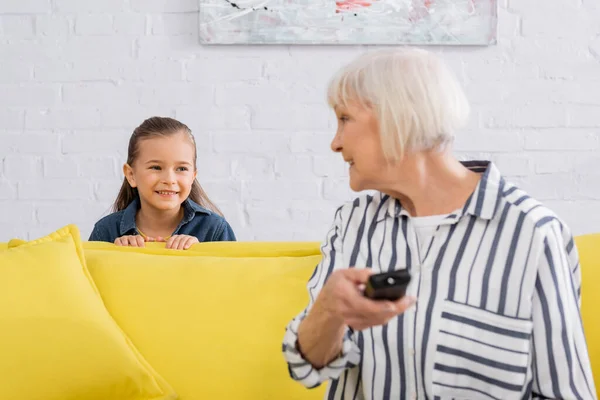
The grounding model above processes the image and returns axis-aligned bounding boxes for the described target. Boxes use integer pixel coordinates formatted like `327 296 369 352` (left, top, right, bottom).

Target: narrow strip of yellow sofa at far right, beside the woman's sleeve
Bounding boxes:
575 234 600 395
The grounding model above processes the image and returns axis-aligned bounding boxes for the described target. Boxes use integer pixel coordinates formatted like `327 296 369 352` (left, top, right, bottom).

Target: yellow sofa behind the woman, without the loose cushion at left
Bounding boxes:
0 230 600 400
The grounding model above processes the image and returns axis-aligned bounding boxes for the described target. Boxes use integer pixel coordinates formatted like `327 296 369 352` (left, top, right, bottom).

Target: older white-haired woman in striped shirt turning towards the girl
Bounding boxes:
283 50 596 400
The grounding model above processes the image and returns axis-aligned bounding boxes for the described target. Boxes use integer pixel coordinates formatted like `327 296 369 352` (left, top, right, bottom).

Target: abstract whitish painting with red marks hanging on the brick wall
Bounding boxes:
199 0 498 45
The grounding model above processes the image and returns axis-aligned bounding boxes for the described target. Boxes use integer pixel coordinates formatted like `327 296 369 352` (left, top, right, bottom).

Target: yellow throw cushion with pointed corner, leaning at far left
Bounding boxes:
0 226 176 400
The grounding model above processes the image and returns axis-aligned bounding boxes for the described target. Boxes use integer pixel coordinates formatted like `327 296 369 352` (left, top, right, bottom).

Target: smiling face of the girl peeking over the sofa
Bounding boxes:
123 132 196 211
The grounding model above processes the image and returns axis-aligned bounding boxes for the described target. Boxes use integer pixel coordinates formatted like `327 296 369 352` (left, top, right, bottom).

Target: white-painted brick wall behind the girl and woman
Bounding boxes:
0 0 600 241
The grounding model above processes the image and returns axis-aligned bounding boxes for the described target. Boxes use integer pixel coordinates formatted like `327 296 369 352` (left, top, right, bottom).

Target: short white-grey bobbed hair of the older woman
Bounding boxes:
327 48 470 161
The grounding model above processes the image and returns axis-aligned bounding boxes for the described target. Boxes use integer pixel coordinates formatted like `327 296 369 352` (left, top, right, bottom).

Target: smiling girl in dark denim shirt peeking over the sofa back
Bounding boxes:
89 117 236 250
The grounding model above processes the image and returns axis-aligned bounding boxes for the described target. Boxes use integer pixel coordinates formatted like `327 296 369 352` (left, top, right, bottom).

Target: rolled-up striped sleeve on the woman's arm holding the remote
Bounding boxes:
283 208 360 388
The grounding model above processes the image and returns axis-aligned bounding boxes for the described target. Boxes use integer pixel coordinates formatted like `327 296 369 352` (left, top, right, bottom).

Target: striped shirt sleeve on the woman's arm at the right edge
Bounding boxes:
532 222 597 399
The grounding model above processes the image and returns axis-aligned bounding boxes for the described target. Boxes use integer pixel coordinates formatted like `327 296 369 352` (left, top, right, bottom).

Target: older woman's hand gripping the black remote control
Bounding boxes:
314 268 416 330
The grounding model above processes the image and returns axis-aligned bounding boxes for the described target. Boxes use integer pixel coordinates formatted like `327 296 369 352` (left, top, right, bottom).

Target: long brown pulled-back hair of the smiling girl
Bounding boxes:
112 117 223 216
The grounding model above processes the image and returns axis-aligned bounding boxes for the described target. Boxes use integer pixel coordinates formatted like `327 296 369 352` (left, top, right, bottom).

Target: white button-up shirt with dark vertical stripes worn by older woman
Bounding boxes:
283 161 596 400
